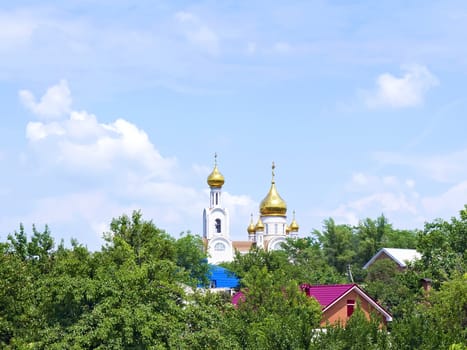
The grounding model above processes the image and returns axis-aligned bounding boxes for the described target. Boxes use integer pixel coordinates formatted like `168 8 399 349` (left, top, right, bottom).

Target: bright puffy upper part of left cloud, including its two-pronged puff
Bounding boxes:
21 80 175 178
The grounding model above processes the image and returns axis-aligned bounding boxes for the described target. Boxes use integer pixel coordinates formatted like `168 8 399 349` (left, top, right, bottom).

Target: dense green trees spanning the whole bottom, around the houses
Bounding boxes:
0 207 467 350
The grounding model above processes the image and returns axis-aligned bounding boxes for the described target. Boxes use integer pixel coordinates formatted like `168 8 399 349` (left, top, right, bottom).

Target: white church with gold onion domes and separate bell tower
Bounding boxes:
203 155 299 264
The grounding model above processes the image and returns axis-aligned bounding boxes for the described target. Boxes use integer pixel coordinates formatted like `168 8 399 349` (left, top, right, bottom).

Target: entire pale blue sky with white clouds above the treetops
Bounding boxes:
0 0 467 250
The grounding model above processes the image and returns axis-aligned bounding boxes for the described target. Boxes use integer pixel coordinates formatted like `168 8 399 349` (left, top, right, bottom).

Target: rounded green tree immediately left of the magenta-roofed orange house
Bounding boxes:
229 267 321 349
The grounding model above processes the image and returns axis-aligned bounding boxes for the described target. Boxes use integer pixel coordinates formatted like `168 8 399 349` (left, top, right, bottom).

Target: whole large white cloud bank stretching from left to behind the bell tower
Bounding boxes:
19 80 257 245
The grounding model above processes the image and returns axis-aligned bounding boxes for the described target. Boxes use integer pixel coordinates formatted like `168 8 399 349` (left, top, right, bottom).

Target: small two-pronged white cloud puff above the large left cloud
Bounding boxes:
19 80 71 120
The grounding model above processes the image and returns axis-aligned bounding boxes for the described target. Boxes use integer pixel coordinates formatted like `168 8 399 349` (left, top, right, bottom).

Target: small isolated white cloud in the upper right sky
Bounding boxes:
363 65 439 108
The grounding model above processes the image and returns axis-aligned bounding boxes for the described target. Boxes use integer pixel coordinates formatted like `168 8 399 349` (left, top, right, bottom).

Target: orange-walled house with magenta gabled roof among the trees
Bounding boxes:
300 284 392 327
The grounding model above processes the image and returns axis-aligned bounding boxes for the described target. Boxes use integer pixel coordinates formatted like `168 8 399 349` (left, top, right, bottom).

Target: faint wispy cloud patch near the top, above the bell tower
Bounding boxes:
175 11 219 55
